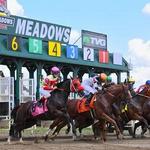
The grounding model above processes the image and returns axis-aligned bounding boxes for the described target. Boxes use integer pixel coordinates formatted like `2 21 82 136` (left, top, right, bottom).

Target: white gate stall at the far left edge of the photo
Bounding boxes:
0 77 14 120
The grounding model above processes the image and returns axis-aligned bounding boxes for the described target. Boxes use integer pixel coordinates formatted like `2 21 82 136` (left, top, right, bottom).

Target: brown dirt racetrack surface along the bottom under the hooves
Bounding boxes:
0 135 150 150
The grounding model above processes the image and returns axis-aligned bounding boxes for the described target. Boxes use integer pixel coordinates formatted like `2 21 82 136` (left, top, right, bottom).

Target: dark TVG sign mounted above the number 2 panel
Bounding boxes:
82 30 107 50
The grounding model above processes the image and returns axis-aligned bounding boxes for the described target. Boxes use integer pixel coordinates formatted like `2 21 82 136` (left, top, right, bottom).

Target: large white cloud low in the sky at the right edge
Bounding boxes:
127 38 150 86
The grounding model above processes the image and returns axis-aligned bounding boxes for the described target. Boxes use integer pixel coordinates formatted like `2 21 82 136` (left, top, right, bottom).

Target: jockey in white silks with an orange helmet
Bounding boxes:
81 73 107 106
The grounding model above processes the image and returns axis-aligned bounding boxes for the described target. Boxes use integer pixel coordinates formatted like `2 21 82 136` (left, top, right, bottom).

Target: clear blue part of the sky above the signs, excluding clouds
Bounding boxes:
18 0 150 54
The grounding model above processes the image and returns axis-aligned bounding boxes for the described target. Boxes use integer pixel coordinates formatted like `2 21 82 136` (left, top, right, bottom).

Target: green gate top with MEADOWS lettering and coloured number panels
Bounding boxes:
0 16 128 72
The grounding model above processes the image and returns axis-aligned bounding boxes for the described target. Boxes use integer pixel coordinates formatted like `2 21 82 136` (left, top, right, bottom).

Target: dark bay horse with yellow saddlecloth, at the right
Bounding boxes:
110 88 150 137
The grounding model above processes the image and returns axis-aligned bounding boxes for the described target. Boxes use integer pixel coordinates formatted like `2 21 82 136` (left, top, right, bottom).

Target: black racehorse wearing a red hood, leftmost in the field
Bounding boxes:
8 78 83 142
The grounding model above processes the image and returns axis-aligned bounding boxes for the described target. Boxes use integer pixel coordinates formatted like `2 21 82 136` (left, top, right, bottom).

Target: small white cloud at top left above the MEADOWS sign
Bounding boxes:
7 0 24 16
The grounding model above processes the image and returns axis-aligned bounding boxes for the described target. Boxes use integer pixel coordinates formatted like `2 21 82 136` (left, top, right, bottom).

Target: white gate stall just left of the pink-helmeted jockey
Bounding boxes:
19 79 36 103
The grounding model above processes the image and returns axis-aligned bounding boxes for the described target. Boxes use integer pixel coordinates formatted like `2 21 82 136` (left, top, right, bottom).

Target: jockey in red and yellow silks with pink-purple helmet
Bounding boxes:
40 67 60 99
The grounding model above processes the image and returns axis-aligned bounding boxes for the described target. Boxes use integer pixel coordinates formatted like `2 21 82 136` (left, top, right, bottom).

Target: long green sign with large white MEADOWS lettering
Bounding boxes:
0 16 71 44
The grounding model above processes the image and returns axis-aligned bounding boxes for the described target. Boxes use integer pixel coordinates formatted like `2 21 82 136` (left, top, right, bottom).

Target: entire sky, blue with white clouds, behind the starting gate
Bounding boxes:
0 0 150 86
